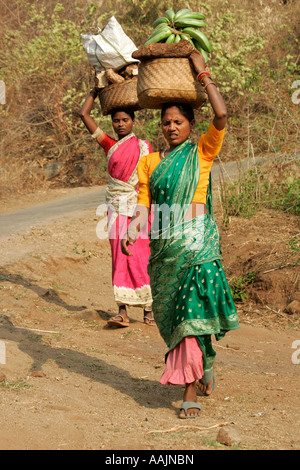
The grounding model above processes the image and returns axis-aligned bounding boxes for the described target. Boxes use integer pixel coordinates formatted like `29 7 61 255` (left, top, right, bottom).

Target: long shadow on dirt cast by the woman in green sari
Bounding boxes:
0 315 177 412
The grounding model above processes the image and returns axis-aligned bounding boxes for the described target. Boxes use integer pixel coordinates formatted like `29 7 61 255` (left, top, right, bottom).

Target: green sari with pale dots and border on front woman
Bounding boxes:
148 139 239 372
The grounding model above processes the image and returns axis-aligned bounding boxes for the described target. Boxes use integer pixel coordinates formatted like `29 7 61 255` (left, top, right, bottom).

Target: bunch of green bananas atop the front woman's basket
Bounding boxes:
144 8 212 62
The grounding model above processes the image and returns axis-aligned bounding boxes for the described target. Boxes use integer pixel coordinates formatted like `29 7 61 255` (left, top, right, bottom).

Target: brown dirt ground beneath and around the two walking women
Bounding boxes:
0 183 300 451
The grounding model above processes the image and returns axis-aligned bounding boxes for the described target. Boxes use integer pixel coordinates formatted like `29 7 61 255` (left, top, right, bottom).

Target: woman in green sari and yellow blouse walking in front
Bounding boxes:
122 51 239 418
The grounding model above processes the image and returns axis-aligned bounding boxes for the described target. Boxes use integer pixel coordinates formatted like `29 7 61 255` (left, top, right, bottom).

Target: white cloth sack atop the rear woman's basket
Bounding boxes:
81 16 138 73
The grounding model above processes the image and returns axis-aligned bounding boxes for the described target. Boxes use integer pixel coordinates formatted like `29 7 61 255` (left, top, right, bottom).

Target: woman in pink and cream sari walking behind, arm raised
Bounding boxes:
80 88 155 327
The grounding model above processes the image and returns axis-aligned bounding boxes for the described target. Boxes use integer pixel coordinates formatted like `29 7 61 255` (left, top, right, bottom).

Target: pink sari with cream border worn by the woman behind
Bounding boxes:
106 134 152 310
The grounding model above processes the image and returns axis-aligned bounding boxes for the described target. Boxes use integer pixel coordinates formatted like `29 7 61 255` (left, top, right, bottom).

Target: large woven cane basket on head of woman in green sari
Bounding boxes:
137 58 206 109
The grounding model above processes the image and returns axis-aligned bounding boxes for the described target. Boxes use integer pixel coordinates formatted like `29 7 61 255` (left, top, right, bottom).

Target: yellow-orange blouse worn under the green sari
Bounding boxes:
137 123 225 208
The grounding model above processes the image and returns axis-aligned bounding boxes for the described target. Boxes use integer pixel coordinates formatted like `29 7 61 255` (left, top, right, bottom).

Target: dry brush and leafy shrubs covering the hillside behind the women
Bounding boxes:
0 0 299 195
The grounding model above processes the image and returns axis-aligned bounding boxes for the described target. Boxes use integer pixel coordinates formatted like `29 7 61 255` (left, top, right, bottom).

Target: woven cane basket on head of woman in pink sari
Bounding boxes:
99 77 140 116
